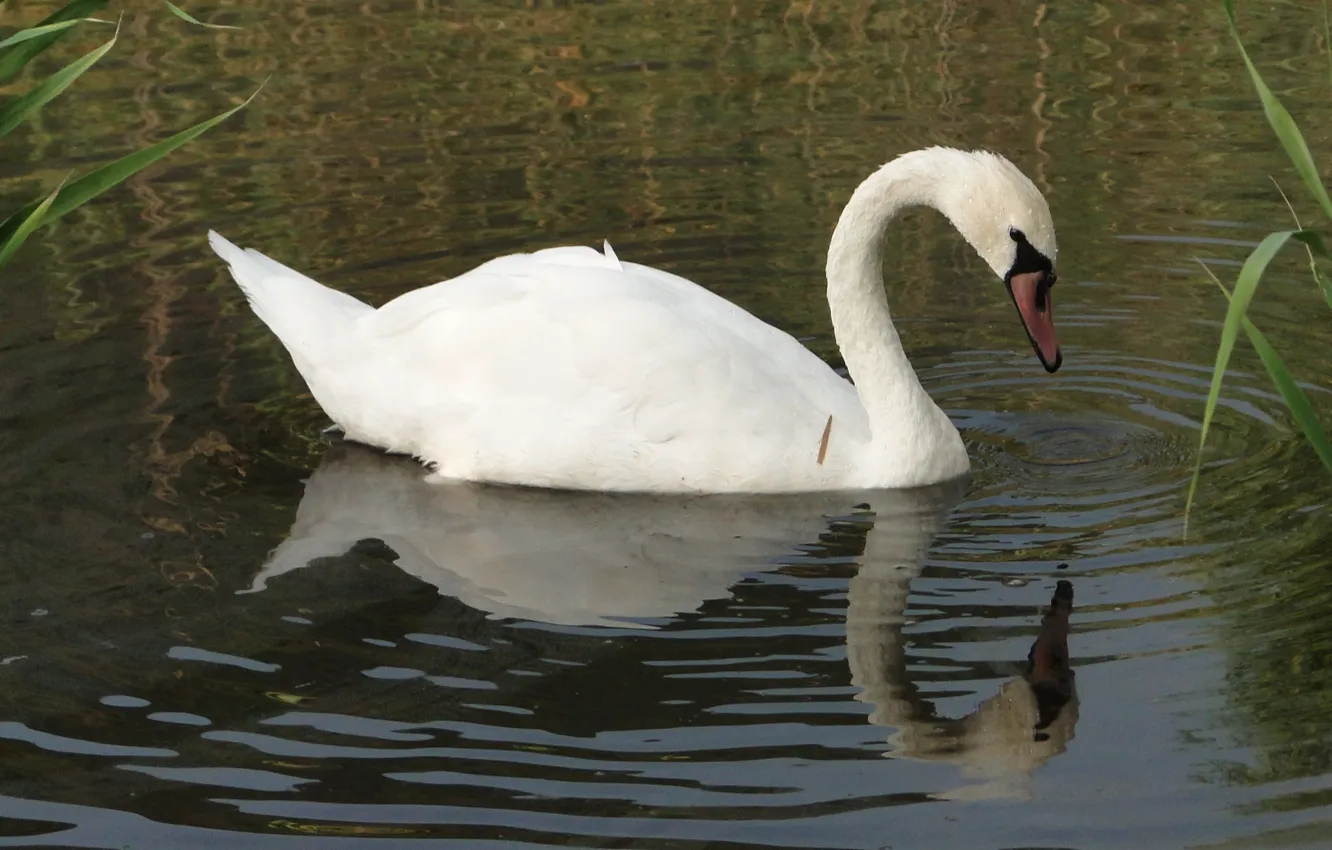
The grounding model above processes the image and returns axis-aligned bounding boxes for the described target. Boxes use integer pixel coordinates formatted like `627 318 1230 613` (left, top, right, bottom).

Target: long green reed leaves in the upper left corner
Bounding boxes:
0 0 262 273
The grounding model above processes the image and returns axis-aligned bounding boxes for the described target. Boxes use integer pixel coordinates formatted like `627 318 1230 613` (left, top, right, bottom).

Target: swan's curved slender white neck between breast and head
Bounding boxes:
827 155 951 449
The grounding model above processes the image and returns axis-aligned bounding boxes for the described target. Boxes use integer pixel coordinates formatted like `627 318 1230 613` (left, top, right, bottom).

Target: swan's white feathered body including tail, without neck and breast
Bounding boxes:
210 234 870 492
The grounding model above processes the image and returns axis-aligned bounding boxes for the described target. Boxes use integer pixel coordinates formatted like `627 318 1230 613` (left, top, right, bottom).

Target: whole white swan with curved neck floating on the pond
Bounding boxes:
208 148 1060 493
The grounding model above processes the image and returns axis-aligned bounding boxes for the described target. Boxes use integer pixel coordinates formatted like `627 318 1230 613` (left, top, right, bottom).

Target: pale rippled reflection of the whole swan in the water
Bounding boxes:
250 442 1078 799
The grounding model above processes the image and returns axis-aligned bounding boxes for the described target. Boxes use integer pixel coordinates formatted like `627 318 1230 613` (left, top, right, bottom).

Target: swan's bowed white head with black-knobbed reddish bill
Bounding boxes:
932 148 1063 372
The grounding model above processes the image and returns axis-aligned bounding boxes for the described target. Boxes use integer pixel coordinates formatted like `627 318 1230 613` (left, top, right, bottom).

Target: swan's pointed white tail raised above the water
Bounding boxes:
208 230 373 367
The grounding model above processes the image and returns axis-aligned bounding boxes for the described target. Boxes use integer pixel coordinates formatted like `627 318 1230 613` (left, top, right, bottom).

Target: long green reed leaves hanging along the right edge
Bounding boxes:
1184 0 1332 517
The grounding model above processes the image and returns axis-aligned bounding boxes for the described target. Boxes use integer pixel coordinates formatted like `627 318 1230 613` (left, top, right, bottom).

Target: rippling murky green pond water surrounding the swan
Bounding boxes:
0 0 1332 850
